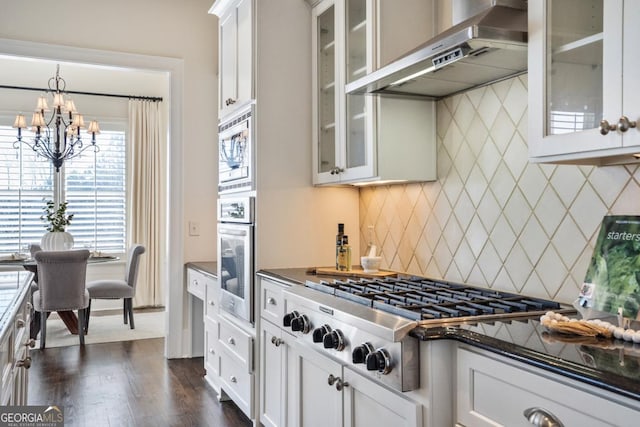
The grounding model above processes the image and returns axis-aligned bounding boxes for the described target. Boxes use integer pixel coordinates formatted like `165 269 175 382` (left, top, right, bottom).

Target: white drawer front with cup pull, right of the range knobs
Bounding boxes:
456 346 640 427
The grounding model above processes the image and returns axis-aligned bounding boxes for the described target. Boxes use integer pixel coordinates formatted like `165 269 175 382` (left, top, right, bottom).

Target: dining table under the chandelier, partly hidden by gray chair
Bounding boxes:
0 253 120 339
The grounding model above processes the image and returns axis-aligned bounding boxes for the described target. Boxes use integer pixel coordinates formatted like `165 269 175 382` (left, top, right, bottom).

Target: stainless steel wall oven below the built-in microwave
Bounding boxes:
218 197 254 323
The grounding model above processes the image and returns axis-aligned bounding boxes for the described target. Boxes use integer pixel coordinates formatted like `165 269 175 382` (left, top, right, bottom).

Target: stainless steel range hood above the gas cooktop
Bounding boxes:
346 0 527 99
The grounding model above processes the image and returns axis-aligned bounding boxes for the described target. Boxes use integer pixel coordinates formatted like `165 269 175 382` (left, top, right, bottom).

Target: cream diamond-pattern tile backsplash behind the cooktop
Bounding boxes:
360 75 640 303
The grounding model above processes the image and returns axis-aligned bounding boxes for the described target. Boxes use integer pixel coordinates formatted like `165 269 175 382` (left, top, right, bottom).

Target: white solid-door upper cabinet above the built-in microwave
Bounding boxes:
209 0 254 117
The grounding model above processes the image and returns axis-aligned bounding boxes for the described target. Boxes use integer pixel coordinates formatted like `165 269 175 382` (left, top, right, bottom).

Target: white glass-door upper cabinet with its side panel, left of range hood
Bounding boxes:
312 0 436 184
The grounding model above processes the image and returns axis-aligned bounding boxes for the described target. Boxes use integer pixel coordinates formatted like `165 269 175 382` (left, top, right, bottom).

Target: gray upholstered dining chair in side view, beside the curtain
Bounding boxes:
86 244 145 331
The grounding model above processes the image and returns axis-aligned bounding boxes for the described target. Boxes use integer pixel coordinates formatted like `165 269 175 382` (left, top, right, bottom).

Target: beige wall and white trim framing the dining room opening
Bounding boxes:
0 0 217 357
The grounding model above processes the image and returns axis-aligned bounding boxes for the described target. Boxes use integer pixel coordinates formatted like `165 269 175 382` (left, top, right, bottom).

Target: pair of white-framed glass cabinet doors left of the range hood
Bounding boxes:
312 0 373 184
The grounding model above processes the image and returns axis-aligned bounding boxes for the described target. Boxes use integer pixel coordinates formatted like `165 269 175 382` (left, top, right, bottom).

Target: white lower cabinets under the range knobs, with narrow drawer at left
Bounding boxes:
259 278 422 427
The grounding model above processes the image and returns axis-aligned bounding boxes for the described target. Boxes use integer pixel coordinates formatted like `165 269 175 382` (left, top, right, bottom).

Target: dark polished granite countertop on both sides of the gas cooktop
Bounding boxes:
258 268 640 401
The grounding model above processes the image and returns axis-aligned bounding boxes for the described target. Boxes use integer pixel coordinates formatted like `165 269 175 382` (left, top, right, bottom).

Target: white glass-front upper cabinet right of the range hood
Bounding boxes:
528 0 640 165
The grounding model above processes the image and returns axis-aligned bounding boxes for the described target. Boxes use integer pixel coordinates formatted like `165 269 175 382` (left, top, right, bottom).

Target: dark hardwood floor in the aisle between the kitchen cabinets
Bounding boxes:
29 338 251 427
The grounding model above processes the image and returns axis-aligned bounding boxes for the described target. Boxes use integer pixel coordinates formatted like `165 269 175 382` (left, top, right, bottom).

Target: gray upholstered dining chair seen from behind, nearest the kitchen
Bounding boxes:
33 249 90 348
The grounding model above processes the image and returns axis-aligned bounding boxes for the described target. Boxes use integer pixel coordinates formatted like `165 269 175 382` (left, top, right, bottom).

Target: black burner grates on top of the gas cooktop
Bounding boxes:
306 277 561 321
